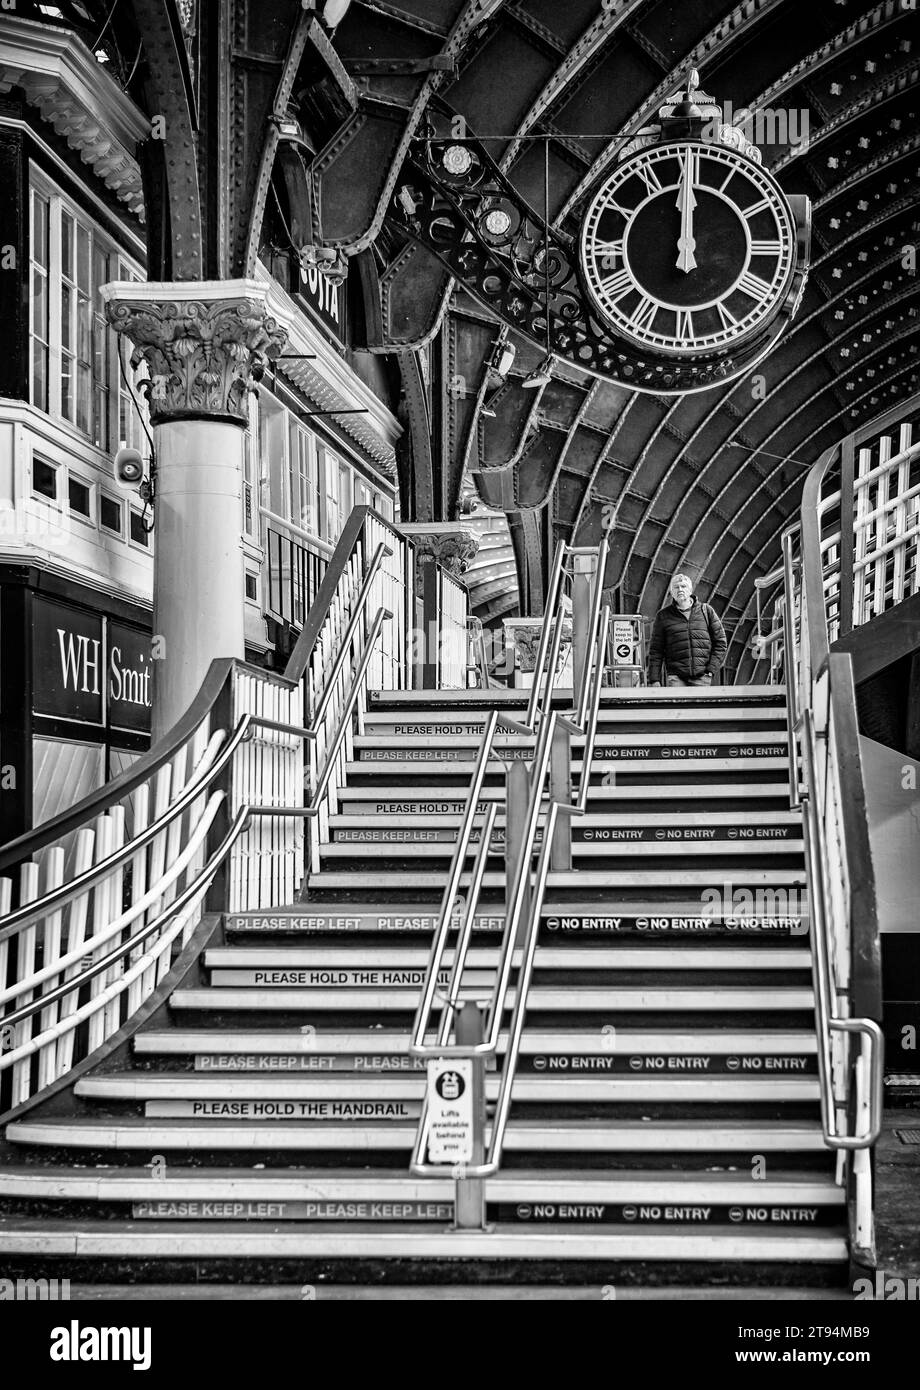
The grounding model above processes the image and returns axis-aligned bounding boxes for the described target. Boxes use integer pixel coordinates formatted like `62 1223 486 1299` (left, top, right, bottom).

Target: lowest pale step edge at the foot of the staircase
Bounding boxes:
0 1218 846 1265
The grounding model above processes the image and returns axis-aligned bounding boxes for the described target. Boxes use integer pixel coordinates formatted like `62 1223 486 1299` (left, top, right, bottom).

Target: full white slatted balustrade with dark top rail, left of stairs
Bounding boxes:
0 507 466 1116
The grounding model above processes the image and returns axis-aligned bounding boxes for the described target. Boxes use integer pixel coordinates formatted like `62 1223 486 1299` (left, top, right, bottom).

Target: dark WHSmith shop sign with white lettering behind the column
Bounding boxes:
32 596 151 735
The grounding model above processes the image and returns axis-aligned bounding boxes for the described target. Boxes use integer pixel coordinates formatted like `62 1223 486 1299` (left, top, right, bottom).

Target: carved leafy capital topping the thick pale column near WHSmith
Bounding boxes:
101 279 288 425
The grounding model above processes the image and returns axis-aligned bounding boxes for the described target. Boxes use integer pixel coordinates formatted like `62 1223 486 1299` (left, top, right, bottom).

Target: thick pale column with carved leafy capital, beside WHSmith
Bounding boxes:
103 281 286 738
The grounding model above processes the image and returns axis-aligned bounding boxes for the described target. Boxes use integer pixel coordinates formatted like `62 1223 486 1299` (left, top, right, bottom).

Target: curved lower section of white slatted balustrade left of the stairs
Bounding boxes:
0 662 249 1112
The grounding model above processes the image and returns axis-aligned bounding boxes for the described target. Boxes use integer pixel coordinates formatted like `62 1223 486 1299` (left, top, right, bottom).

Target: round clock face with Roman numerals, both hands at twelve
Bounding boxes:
581 142 796 357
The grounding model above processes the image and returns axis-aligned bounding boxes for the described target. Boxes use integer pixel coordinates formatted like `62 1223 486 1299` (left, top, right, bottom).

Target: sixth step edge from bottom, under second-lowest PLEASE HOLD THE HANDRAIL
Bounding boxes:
170 986 814 1013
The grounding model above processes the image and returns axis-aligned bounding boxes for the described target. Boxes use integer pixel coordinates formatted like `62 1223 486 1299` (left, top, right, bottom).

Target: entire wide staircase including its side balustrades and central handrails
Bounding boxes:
0 378 917 1298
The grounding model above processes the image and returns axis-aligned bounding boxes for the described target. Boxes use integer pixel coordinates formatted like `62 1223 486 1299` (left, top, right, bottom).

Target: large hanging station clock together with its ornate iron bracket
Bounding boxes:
393 72 810 395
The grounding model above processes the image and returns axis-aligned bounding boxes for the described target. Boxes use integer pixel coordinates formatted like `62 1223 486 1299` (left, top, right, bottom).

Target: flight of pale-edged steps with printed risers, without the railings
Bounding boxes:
0 688 846 1284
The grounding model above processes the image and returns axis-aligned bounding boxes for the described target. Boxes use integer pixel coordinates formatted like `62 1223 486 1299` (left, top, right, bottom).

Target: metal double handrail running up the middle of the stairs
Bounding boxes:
410 537 610 1229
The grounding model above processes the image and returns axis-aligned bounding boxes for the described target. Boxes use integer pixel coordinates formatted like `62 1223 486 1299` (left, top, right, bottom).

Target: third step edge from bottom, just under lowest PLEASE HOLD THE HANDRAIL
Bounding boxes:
0 1116 827 1156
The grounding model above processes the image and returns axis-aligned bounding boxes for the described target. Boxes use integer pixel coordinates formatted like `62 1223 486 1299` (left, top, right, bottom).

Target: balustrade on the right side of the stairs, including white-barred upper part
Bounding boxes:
759 396 920 1264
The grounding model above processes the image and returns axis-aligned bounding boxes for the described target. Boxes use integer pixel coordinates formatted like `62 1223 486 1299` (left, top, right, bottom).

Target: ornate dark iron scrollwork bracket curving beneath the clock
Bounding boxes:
391 138 785 395
